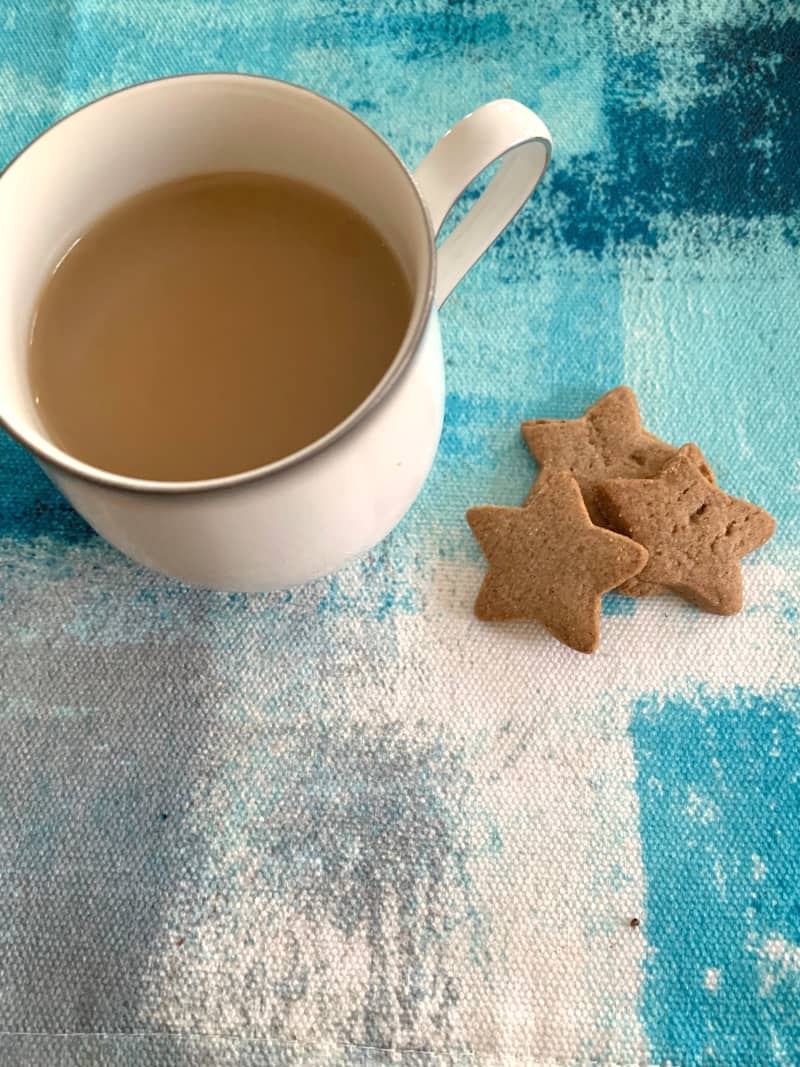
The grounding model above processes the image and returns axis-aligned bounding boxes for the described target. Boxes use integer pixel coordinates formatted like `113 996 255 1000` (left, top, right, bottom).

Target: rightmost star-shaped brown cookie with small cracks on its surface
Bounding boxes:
597 449 775 615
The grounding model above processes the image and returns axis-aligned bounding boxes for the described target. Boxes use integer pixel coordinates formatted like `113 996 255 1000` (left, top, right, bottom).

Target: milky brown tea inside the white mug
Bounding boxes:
29 172 412 481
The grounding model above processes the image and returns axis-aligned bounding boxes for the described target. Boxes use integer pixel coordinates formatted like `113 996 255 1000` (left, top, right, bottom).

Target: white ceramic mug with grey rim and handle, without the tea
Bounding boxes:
0 75 550 591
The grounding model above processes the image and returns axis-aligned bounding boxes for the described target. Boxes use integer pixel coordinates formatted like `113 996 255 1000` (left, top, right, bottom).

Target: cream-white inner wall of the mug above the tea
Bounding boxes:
0 75 434 490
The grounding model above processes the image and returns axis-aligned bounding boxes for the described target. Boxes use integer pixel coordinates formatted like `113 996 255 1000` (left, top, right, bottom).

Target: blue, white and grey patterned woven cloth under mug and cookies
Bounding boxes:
0 0 800 1067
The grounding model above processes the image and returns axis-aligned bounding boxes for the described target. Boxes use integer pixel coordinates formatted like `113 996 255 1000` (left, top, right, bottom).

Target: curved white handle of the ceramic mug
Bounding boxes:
414 100 553 307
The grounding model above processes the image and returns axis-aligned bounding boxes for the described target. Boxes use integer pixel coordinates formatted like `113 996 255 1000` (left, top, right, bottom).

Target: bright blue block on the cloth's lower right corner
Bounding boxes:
630 686 800 1067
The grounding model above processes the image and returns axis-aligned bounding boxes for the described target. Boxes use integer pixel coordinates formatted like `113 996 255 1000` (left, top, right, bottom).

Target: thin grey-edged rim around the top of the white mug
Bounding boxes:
0 70 436 495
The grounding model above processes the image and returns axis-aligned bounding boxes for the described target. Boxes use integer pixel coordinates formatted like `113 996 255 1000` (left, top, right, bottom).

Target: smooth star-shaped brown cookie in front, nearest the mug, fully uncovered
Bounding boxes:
467 472 647 652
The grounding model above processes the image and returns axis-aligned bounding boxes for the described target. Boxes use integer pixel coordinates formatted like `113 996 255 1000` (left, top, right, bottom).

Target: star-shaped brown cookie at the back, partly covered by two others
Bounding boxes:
522 385 714 526
